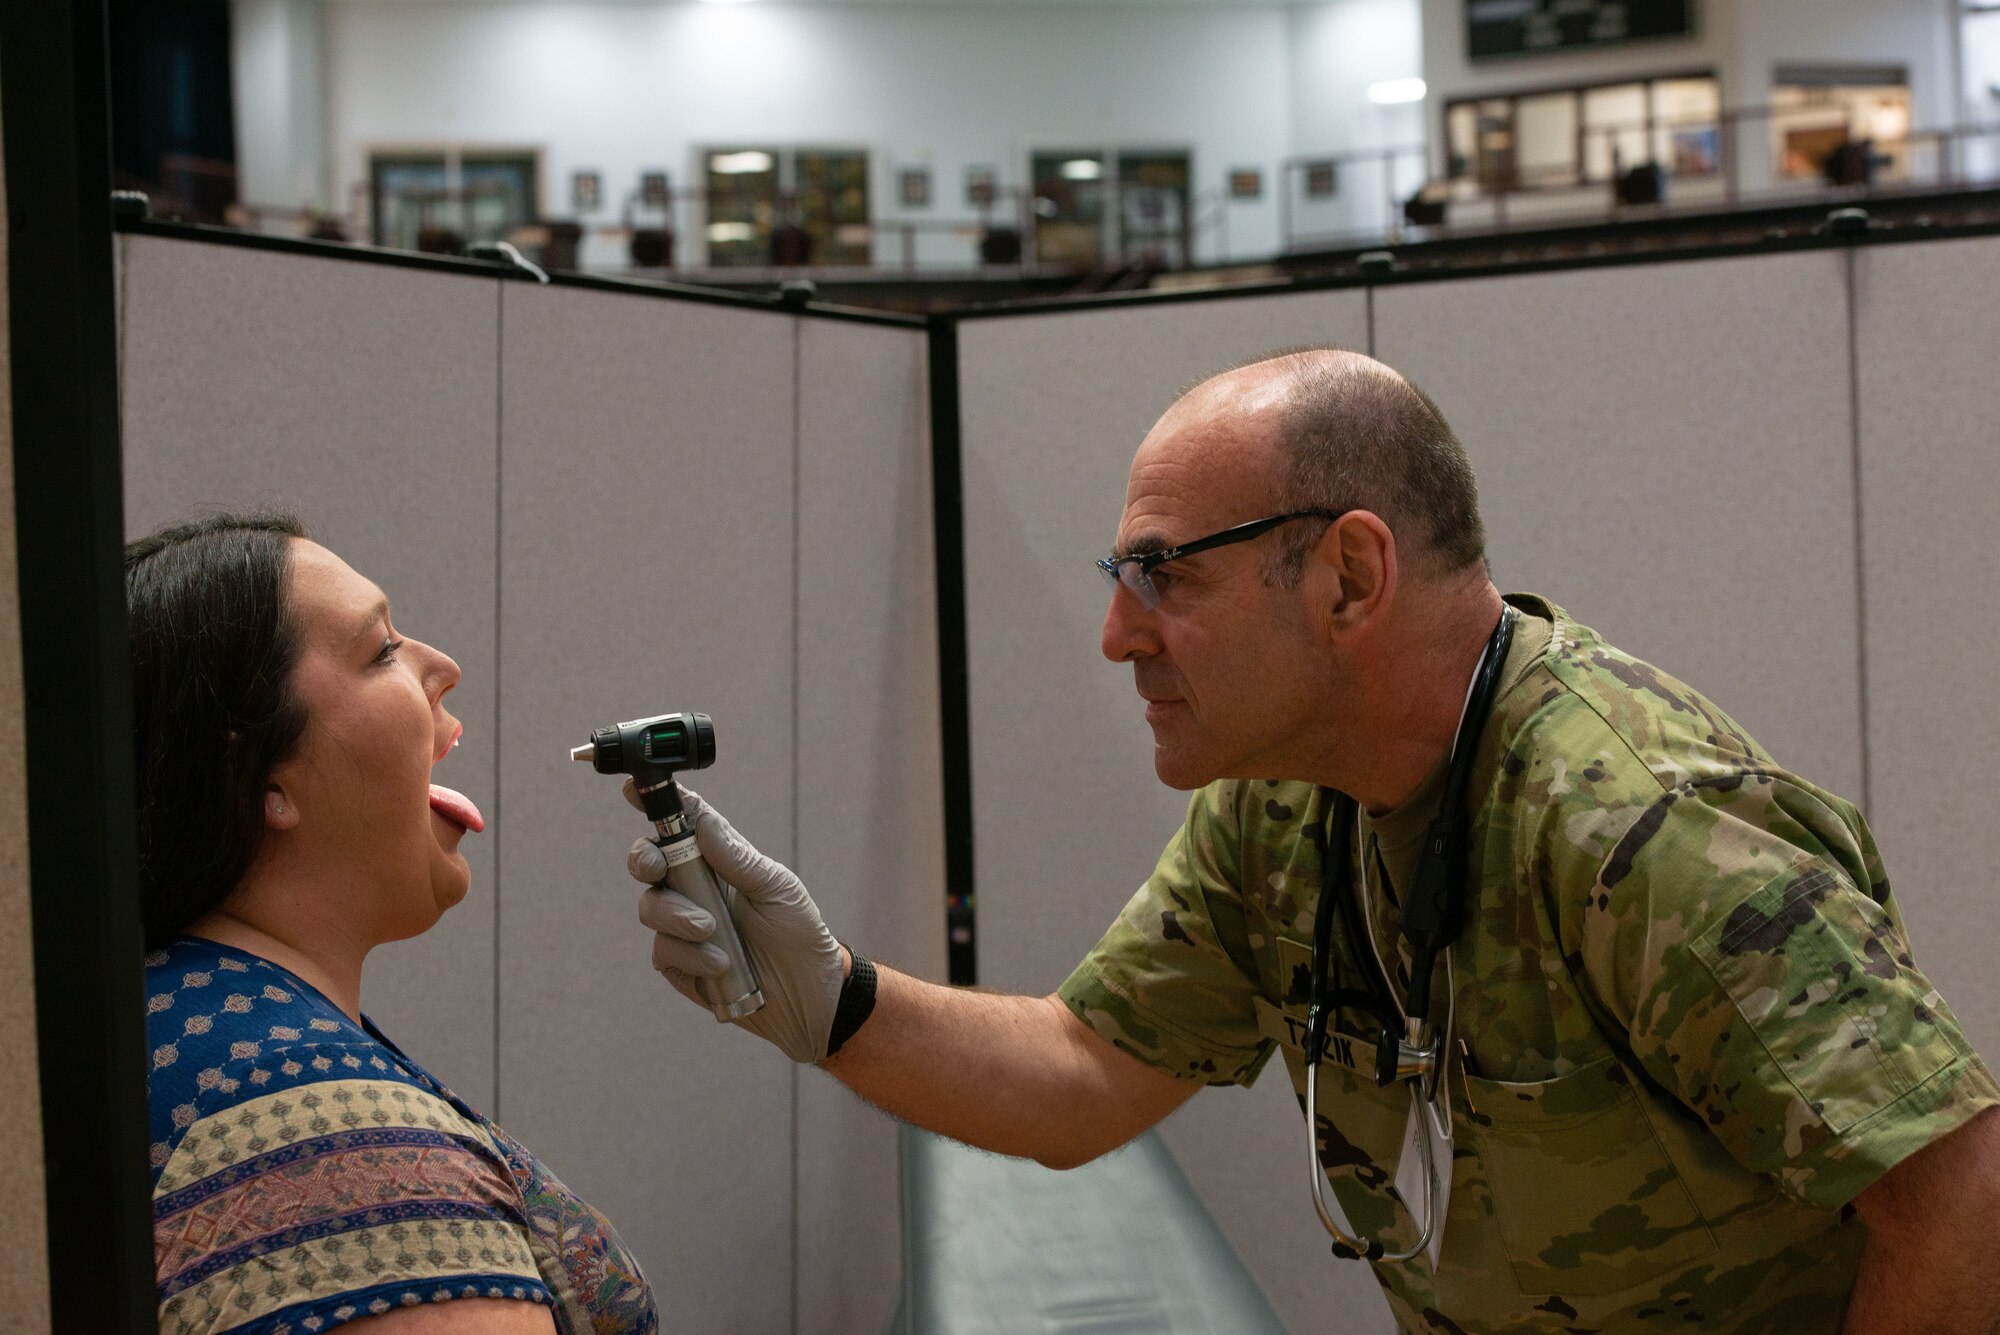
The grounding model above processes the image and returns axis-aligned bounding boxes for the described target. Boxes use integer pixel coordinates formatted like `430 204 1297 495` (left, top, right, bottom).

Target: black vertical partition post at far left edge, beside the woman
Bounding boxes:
0 0 158 1335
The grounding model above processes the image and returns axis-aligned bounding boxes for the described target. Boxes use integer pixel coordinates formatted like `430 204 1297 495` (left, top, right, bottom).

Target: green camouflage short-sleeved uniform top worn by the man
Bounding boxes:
1062 596 2000 1335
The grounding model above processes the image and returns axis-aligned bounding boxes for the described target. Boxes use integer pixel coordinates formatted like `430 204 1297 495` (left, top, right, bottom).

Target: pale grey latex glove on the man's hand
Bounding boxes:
626 779 846 1061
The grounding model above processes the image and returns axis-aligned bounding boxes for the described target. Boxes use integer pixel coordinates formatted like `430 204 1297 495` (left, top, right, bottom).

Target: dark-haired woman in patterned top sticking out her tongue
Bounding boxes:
126 514 658 1335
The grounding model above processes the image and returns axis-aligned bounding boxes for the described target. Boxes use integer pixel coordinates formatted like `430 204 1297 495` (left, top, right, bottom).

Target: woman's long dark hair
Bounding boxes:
126 510 306 947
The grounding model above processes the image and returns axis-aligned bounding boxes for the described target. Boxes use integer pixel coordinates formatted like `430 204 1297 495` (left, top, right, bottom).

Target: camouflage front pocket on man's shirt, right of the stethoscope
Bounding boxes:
1466 1057 1716 1295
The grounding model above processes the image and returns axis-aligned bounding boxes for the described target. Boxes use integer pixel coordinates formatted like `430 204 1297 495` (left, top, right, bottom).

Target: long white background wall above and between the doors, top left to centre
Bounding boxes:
326 0 1320 260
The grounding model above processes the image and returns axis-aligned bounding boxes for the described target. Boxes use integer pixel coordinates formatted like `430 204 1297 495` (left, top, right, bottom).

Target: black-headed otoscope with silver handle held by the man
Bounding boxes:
570 713 764 1023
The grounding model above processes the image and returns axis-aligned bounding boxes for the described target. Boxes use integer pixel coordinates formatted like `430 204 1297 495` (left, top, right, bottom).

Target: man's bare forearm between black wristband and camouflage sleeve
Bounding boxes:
822 965 1192 1167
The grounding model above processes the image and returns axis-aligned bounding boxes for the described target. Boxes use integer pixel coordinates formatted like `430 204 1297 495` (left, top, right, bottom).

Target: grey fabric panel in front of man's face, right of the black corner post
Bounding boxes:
958 290 1390 1331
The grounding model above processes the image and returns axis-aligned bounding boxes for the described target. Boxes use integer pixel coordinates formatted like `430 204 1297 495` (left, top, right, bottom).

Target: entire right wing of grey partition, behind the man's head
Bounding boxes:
958 240 2000 1331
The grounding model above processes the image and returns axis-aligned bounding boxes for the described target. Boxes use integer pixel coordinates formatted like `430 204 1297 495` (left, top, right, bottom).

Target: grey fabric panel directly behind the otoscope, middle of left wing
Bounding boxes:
496 284 798 1331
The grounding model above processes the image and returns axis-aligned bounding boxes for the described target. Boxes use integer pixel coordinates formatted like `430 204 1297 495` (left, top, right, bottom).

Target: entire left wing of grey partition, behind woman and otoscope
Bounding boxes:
122 234 944 1335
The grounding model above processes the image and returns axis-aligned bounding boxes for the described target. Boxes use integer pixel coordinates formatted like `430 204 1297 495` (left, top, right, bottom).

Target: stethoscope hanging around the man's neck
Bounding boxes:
1306 606 1520 1261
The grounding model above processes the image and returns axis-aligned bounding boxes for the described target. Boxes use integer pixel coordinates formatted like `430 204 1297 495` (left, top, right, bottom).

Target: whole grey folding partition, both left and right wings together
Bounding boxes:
122 218 2000 1333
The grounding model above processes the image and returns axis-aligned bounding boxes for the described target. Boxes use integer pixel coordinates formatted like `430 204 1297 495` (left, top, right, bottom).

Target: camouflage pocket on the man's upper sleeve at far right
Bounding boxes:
1692 865 1960 1135
